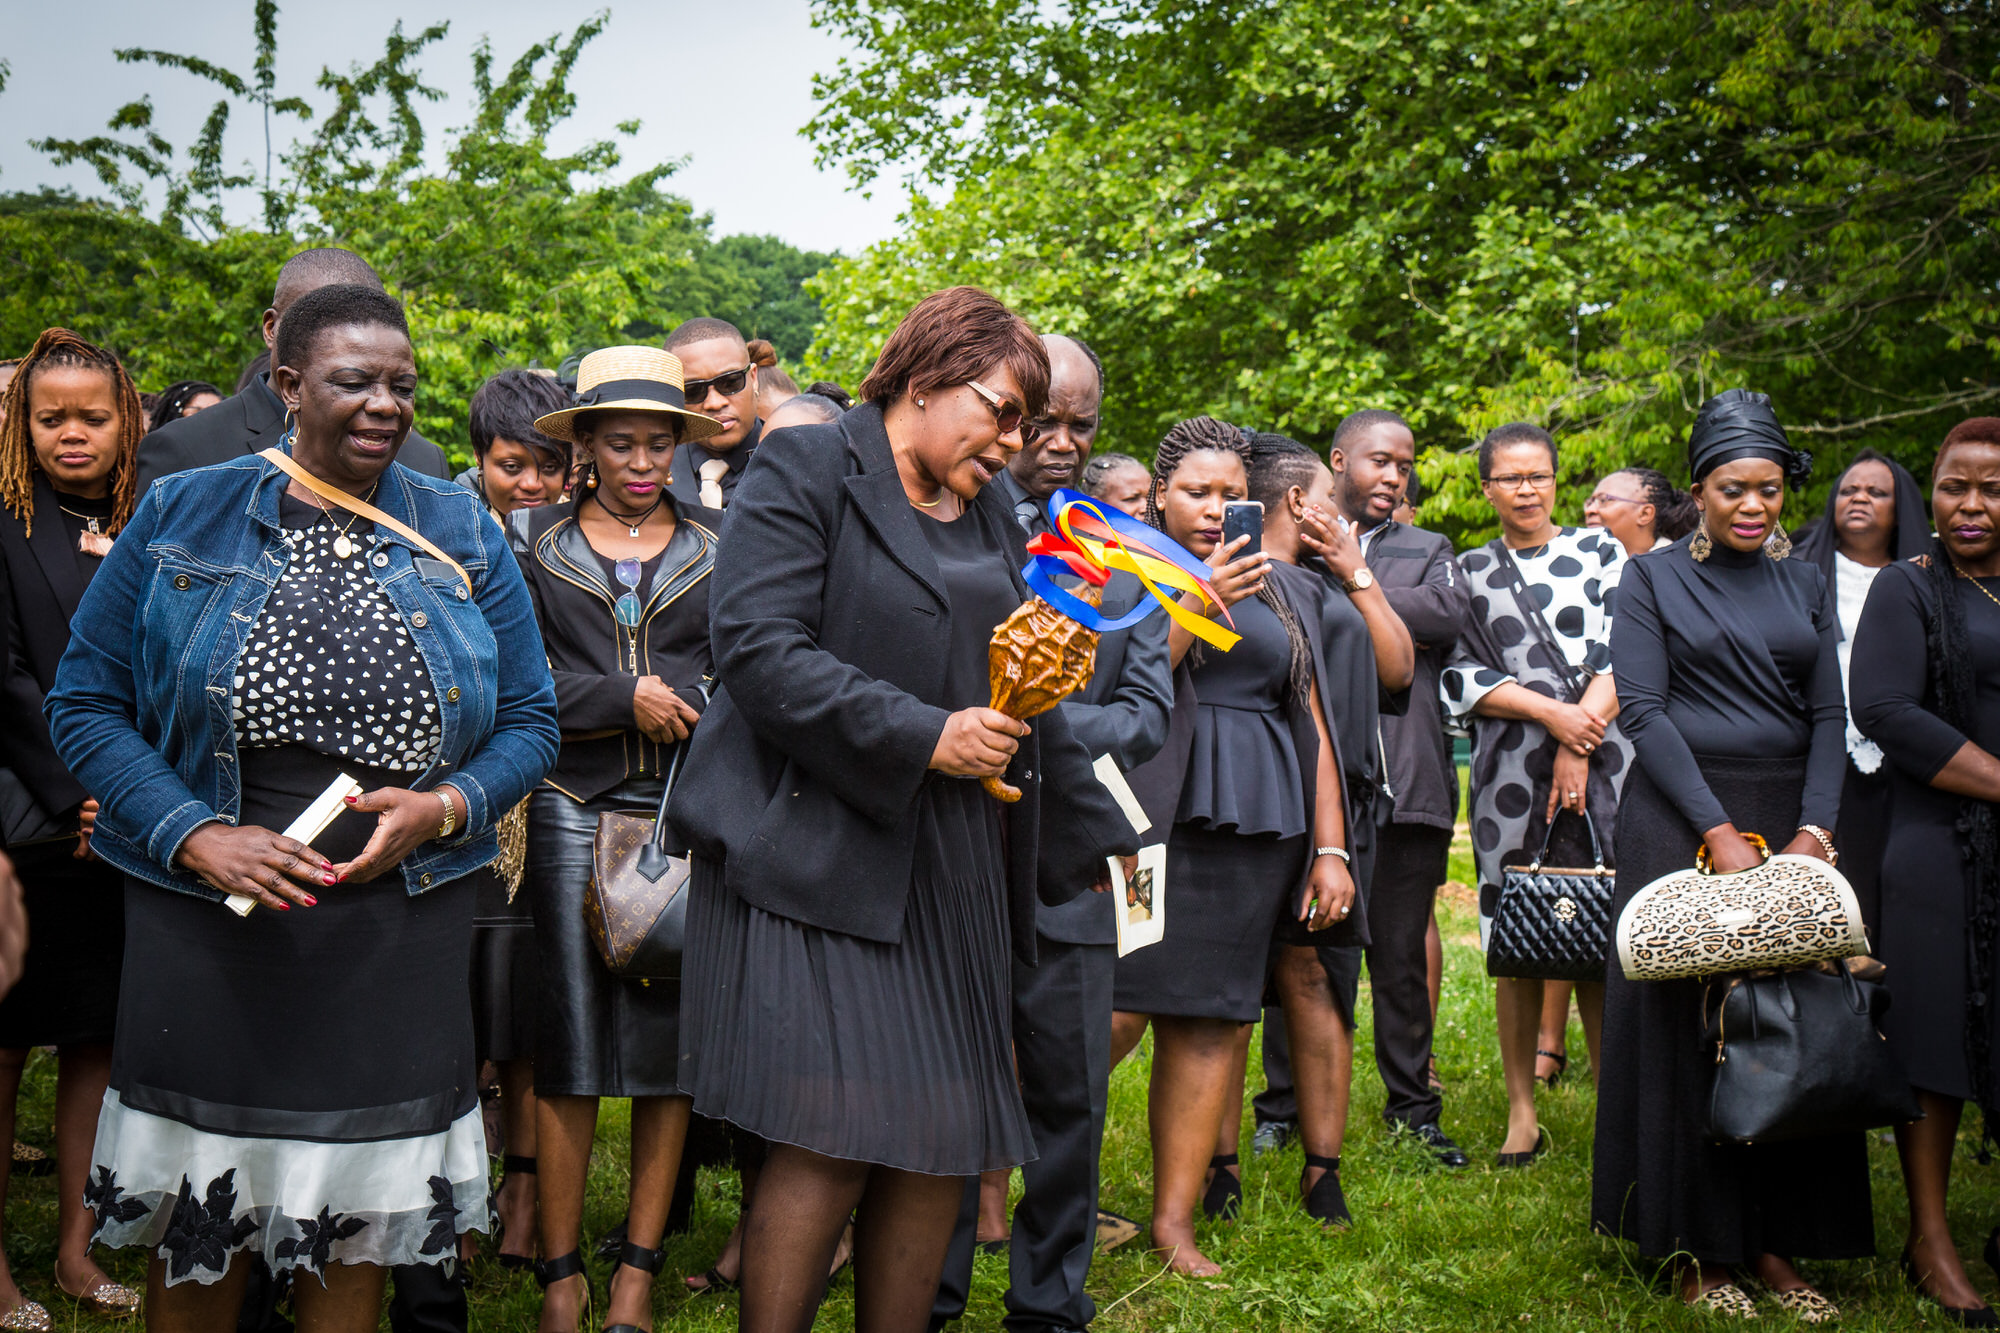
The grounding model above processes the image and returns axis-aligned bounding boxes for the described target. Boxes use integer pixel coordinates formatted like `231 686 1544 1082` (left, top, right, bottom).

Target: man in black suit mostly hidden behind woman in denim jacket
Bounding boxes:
138 248 452 494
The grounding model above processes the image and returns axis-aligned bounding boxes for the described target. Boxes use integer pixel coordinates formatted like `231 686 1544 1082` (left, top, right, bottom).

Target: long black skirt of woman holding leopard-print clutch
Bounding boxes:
1590 757 1874 1263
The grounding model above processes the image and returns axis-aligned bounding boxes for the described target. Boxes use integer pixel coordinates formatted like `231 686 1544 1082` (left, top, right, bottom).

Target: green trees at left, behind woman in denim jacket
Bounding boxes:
0 0 832 460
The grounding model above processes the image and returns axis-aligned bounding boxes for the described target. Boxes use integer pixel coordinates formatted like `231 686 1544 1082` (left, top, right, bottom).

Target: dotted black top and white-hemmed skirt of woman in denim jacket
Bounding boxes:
86 496 486 1285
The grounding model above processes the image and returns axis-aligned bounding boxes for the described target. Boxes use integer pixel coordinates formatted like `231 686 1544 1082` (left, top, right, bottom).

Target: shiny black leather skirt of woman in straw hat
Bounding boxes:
522 779 680 1097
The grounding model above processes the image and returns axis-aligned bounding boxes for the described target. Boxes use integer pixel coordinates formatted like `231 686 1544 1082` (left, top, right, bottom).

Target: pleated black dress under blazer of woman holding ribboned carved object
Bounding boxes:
682 508 1034 1175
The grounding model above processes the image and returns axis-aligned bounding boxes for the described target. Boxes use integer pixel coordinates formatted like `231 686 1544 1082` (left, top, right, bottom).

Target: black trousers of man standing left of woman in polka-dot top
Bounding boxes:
1252 825 1452 1125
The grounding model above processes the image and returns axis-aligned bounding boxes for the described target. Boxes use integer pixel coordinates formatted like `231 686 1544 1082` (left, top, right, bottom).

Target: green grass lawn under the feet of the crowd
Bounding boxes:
6 824 2000 1333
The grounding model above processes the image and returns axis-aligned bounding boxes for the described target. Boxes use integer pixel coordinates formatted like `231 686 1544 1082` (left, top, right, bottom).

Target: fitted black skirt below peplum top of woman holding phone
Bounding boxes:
1112 825 1306 1023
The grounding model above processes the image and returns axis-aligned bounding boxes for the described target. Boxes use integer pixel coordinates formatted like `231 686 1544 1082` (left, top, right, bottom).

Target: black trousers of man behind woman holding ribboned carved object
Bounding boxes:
932 937 1118 1333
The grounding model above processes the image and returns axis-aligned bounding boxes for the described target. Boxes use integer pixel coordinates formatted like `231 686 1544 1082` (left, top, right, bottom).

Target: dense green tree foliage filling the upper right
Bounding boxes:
810 0 2000 536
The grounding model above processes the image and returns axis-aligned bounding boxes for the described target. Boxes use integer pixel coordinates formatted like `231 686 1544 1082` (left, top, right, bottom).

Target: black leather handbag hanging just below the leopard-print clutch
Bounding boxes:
1702 965 1924 1143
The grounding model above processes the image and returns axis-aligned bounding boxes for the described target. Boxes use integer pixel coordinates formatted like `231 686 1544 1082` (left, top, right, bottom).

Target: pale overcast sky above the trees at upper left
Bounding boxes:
0 0 900 252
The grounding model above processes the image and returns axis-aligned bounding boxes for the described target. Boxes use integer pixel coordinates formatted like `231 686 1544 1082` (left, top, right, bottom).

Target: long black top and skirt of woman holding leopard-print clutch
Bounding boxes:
1590 544 1874 1263
